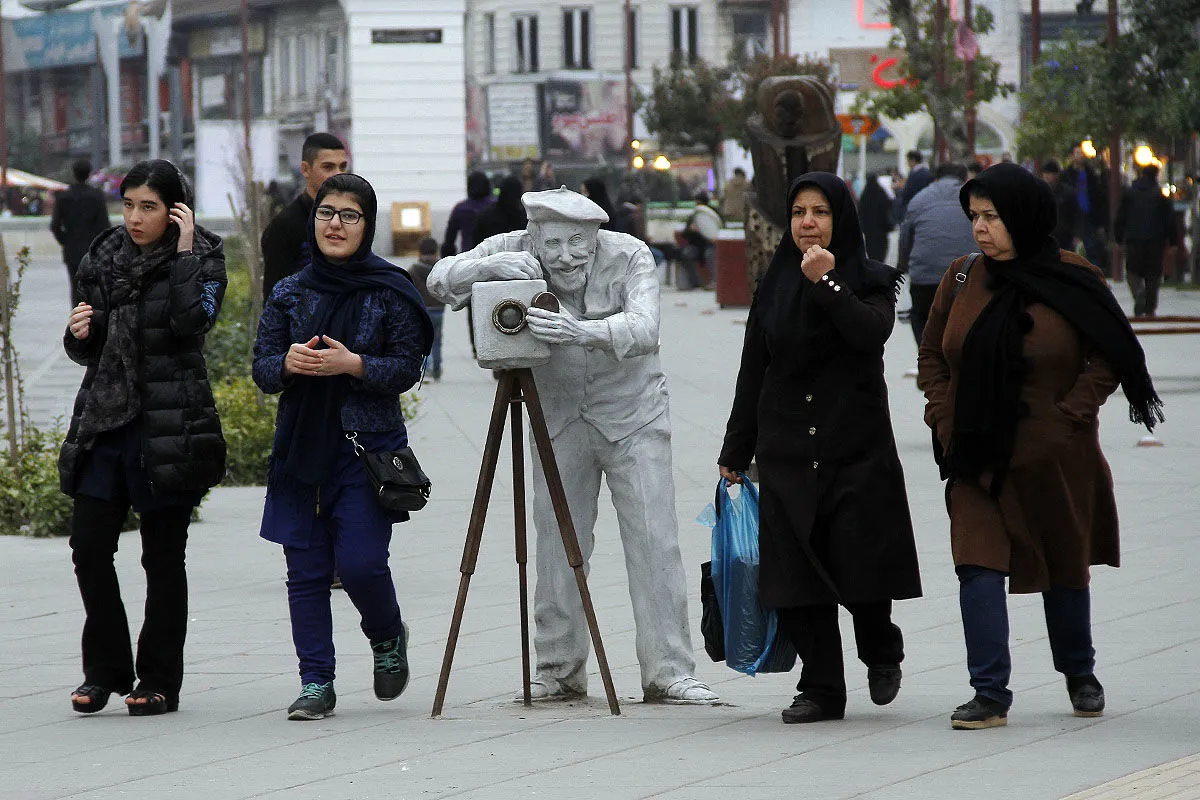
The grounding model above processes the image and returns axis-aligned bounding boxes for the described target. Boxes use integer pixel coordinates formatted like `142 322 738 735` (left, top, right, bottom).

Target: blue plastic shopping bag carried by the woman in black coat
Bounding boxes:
697 475 796 675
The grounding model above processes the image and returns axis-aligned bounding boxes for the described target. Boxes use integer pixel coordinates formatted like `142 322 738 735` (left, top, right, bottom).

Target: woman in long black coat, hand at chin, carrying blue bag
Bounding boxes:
718 173 920 723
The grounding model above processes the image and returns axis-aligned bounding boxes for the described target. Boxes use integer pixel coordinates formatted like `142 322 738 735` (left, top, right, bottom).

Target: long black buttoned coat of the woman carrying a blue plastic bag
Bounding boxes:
719 266 920 608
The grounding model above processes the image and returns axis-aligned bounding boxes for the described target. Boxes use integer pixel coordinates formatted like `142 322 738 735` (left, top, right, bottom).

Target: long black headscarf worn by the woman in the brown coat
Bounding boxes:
948 163 1164 494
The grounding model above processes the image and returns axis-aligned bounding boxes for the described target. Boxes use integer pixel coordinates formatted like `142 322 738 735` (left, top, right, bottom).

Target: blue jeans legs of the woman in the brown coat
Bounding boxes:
955 565 1096 706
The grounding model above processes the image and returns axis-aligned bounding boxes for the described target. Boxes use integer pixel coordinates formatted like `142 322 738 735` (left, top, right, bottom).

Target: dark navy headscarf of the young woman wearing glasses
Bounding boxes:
271 174 433 487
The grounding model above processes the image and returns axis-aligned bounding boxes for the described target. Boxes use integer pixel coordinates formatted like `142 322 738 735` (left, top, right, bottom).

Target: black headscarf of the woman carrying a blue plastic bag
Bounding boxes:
756 173 901 368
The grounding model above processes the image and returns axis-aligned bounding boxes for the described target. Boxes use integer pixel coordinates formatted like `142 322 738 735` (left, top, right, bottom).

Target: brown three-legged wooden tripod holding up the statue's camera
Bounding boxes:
432 368 620 717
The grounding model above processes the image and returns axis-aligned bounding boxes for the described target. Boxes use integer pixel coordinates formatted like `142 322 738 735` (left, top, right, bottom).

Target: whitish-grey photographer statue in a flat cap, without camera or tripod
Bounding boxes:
428 187 719 703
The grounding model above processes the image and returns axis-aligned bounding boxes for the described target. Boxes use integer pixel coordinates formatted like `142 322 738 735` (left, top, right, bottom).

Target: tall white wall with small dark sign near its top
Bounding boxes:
342 0 467 253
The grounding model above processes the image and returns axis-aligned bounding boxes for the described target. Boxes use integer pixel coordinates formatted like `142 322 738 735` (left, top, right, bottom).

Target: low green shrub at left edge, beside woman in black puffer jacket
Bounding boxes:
0 425 72 536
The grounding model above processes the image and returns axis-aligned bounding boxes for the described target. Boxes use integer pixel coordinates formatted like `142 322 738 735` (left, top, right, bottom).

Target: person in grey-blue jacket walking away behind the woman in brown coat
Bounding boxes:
896 163 976 347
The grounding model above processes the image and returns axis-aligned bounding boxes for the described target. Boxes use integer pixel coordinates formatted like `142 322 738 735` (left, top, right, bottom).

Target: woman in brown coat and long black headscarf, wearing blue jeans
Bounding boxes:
918 163 1163 728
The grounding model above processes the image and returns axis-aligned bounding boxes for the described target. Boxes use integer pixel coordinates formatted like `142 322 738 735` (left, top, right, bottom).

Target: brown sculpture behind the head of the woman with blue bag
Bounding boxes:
745 76 841 293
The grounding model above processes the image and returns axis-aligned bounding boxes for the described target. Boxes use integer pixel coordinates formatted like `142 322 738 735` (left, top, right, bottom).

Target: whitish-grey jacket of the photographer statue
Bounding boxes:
427 230 667 441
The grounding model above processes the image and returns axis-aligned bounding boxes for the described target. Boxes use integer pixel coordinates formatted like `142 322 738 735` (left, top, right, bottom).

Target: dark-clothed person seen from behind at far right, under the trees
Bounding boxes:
1115 164 1180 317
